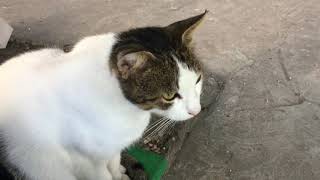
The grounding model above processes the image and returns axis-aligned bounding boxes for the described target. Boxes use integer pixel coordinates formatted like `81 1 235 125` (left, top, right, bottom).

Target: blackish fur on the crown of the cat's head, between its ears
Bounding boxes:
116 27 201 72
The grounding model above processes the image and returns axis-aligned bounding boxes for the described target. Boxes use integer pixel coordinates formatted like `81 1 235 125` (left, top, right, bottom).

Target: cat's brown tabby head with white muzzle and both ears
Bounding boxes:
110 11 207 121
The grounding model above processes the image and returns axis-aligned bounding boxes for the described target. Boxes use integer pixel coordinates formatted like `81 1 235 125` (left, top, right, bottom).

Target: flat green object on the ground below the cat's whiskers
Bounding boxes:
128 147 168 180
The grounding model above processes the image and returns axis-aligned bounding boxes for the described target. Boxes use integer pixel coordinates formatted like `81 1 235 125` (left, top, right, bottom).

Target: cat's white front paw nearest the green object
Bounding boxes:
108 153 130 180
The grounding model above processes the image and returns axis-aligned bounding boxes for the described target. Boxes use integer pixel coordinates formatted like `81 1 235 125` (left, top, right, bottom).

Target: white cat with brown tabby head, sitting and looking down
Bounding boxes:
0 11 207 180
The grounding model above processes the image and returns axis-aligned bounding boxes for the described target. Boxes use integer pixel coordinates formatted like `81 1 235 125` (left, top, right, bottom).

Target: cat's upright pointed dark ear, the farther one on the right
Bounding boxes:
165 10 208 44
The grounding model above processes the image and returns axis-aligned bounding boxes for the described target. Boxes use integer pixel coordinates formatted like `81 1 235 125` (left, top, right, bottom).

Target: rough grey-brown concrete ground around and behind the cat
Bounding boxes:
0 0 320 180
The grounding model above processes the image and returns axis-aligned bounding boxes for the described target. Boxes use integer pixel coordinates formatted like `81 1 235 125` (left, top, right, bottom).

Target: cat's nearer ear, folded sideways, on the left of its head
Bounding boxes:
117 51 154 79
